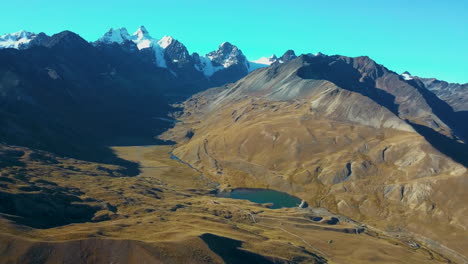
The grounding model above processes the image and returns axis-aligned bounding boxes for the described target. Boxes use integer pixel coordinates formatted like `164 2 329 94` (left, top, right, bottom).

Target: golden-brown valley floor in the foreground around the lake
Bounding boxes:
0 146 458 263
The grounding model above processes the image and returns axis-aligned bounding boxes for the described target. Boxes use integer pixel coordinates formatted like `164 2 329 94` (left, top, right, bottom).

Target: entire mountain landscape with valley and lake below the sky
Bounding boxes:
0 23 468 264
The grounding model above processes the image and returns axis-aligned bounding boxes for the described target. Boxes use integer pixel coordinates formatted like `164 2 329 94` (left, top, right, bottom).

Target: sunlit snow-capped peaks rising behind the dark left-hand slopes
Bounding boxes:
0 26 274 88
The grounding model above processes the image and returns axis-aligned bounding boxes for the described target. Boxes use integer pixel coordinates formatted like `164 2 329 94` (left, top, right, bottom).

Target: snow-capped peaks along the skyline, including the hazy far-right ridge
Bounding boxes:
0 26 468 108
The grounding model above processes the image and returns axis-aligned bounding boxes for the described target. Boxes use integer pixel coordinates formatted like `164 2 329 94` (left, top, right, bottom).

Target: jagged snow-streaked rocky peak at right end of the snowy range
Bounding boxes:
206 42 247 68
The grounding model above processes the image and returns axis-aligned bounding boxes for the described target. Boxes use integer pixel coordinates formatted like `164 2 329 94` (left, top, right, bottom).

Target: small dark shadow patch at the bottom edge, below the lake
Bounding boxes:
200 233 275 264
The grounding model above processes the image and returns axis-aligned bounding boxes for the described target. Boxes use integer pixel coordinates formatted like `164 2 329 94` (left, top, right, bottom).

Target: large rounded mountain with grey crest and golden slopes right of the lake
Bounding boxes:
163 54 468 258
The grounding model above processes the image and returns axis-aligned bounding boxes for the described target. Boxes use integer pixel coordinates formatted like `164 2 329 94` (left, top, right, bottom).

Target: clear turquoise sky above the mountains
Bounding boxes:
0 0 468 83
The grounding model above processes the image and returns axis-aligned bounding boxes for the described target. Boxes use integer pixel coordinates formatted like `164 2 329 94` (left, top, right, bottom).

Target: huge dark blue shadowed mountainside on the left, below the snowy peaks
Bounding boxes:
0 37 181 176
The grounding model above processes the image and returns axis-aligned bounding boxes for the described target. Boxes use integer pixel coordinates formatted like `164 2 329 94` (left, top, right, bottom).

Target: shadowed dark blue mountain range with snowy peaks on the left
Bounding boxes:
0 26 308 160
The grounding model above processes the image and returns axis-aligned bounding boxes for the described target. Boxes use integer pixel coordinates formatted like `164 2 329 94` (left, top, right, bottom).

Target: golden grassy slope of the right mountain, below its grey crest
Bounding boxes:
162 94 468 262
